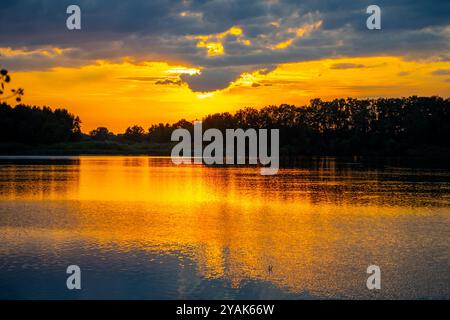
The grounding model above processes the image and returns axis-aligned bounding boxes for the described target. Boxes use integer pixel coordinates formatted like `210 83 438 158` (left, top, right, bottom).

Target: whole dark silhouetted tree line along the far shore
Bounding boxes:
0 96 450 156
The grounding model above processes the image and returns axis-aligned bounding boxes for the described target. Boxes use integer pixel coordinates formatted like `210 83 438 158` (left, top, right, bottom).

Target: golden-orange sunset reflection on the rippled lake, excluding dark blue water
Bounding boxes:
0 157 450 297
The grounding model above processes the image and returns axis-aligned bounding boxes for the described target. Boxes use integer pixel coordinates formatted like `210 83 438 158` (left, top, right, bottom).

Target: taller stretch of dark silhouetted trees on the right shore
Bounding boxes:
149 96 450 155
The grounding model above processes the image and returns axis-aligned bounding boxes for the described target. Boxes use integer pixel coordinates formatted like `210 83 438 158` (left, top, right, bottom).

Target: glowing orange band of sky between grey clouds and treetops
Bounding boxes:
6 52 450 133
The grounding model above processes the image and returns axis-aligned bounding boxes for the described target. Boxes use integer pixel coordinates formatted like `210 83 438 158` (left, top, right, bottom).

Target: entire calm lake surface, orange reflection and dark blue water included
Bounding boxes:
0 157 450 299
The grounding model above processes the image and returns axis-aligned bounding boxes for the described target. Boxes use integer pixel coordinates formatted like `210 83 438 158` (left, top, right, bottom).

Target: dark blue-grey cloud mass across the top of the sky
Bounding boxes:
0 0 450 91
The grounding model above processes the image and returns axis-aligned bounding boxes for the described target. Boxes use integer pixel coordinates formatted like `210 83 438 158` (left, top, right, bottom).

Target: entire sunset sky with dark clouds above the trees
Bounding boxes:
0 0 450 133
